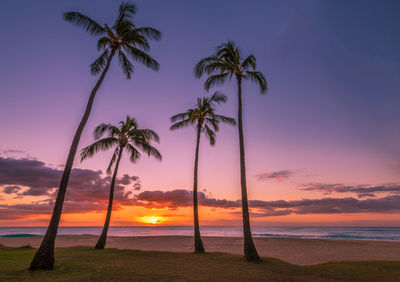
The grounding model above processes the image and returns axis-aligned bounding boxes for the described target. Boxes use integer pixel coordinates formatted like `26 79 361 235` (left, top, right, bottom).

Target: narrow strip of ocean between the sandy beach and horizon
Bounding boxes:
0 226 400 240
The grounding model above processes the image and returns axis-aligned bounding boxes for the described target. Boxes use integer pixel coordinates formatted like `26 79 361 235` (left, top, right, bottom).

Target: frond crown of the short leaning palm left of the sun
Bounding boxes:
81 116 161 167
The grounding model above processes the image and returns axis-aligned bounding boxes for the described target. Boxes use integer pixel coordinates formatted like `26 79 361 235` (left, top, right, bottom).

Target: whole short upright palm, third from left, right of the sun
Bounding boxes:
170 92 236 253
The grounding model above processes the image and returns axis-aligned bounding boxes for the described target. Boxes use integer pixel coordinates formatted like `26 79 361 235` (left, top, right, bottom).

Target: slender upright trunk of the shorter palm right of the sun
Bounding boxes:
193 126 204 253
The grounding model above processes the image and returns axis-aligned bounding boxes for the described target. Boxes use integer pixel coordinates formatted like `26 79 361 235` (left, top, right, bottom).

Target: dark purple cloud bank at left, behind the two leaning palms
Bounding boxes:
0 157 139 201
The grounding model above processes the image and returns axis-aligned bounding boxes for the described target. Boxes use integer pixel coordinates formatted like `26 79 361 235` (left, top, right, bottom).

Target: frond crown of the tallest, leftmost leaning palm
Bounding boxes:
64 2 161 78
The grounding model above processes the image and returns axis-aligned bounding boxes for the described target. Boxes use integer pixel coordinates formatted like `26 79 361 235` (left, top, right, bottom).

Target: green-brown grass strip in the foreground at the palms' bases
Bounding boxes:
0 247 400 281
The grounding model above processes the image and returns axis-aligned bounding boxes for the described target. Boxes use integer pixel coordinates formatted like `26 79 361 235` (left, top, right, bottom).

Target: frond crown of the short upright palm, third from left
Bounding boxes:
170 92 236 142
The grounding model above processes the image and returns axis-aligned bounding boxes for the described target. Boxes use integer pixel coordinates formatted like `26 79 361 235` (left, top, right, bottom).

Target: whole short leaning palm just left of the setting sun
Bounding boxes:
81 116 161 249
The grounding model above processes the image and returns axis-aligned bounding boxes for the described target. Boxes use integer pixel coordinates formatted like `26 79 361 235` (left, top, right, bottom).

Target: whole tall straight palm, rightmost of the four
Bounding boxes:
194 41 267 261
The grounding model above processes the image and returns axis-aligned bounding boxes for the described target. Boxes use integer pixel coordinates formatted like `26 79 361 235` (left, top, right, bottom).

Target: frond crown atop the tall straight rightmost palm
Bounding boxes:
194 41 267 94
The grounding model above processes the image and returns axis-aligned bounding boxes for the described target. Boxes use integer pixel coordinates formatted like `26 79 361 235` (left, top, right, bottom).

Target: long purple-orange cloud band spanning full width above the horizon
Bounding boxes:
0 157 400 220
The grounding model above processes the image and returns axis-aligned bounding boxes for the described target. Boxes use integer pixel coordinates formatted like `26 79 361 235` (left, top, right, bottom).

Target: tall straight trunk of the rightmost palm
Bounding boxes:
237 76 260 261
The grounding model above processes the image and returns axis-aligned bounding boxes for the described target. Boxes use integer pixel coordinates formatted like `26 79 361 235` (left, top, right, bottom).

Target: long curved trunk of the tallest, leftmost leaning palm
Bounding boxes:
29 50 115 270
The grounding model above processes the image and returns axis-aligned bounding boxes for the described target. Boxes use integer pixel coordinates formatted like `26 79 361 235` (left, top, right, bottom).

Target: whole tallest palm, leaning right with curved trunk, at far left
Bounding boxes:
29 3 161 270
